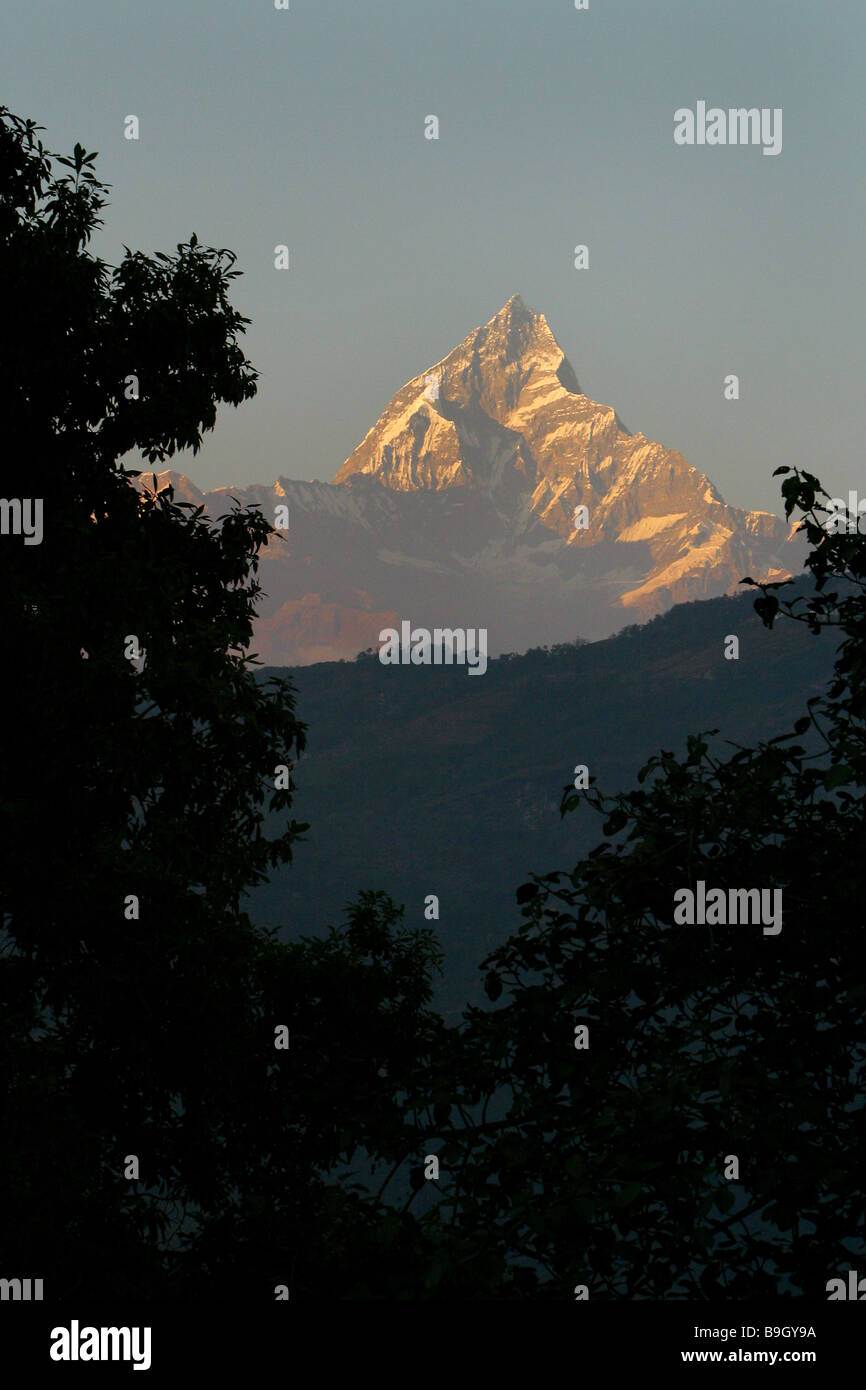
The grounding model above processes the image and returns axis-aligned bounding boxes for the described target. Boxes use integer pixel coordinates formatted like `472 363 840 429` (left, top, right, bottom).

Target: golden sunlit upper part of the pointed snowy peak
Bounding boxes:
334 295 787 600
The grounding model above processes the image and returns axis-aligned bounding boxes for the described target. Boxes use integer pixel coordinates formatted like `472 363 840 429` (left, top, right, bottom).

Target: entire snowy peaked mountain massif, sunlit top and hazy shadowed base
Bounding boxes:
142 295 802 664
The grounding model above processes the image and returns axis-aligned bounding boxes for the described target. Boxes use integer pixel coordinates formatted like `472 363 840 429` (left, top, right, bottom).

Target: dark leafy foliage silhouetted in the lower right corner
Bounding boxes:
417 468 866 1300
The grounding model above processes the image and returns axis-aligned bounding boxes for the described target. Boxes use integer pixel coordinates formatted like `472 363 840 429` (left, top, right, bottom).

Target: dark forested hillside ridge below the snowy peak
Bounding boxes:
250 581 835 1011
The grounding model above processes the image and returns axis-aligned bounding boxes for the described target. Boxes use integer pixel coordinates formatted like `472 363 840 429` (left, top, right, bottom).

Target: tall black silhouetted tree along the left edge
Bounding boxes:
0 108 447 1298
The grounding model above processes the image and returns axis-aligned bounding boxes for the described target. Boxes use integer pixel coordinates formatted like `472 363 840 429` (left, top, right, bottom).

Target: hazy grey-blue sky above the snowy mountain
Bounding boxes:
0 0 866 510
